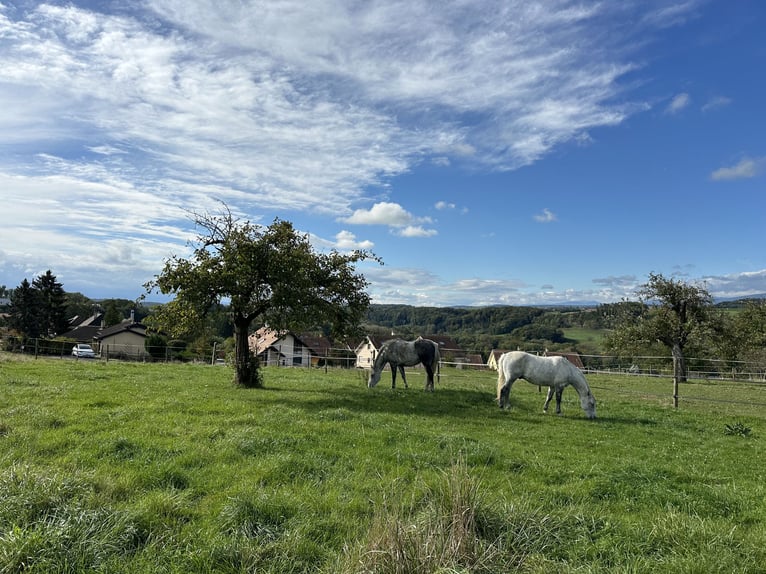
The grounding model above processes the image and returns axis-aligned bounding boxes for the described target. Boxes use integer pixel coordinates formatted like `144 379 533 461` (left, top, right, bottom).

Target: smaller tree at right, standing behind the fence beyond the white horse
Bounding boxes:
606 273 713 404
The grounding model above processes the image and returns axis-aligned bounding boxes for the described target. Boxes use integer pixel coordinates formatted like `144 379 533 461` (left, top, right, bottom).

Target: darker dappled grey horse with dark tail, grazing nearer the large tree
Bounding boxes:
367 337 440 391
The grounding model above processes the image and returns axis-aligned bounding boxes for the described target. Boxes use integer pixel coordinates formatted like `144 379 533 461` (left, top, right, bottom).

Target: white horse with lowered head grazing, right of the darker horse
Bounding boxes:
497 351 596 419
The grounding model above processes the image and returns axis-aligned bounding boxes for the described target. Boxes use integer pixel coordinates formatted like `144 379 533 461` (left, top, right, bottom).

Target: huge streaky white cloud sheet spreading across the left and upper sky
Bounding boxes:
0 0 708 300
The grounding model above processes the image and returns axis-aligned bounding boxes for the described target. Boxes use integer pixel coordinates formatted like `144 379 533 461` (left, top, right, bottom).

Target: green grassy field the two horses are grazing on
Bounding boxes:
0 355 766 574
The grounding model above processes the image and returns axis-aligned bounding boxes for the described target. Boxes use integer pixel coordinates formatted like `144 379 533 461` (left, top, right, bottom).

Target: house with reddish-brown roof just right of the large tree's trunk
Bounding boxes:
248 327 332 367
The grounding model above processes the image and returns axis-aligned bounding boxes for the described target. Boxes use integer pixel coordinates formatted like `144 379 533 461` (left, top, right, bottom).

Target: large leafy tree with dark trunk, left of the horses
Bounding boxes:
145 205 375 387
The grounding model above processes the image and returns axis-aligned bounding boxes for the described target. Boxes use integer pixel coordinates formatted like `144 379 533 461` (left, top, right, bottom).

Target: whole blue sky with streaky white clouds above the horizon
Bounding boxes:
0 0 766 306
